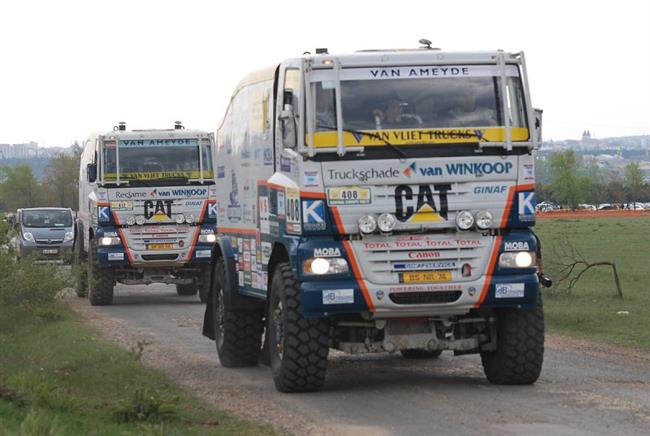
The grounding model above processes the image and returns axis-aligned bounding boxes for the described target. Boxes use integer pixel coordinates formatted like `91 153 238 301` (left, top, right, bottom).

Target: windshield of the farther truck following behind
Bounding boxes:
103 139 213 182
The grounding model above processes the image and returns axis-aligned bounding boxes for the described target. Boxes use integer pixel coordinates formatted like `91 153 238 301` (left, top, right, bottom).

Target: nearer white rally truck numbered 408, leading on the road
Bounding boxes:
203 45 544 392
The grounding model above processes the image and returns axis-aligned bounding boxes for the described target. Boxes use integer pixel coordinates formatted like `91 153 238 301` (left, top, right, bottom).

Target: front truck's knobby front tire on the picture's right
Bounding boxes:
481 294 544 385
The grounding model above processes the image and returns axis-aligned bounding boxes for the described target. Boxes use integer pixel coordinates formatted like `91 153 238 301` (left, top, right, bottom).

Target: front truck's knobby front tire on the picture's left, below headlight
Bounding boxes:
267 263 329 392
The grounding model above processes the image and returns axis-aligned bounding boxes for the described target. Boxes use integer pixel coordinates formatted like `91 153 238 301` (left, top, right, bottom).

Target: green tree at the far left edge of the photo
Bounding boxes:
0 164 44 210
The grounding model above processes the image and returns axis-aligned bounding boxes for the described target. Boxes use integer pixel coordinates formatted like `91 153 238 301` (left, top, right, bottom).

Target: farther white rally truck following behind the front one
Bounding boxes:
74 122 216 305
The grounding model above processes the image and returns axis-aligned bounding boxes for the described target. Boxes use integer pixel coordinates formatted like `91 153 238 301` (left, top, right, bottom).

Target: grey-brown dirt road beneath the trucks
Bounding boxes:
70 285 650 435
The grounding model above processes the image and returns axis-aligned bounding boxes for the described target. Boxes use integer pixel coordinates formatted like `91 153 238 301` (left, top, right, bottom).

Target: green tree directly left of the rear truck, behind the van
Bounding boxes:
43 144 82 210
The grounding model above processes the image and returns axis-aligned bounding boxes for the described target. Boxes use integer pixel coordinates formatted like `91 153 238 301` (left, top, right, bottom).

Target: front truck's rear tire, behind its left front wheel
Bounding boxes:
209 258 264 368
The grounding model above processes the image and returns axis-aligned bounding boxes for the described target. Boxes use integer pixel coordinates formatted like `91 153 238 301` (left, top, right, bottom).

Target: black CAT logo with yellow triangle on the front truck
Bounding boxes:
395 184 451 223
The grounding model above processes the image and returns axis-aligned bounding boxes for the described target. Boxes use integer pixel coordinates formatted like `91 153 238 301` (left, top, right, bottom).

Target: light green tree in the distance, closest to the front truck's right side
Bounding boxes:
550 150 591 209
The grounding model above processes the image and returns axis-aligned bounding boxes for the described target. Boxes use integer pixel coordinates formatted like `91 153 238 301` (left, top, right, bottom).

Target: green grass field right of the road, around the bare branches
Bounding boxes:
535 217 650 351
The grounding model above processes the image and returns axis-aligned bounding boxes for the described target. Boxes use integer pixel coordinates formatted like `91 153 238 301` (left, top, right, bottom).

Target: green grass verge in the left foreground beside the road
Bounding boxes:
0 305 272 435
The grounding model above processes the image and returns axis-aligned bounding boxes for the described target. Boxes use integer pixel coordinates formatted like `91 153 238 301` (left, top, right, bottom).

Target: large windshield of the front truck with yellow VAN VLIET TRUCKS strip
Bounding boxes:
312 66 528 147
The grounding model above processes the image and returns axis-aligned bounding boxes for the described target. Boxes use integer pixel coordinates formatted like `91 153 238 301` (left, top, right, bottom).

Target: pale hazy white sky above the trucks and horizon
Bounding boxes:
0 0 650 146
